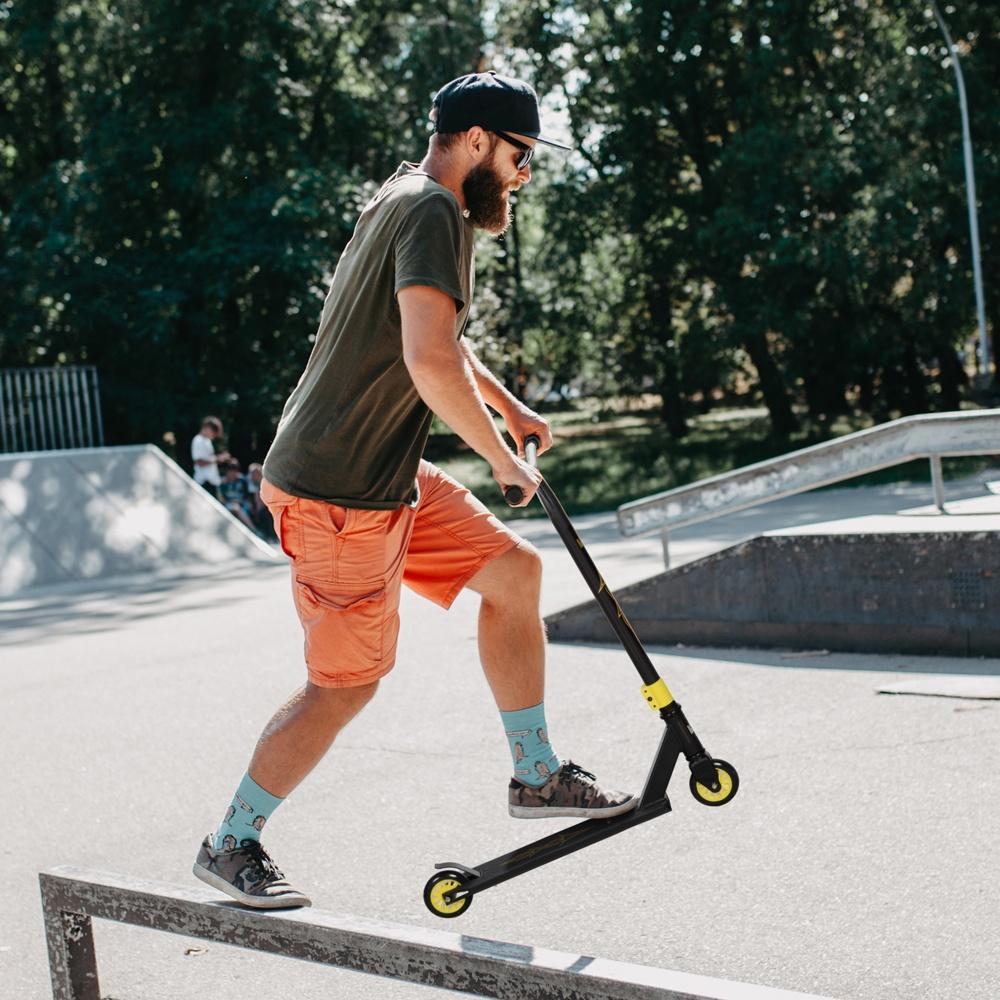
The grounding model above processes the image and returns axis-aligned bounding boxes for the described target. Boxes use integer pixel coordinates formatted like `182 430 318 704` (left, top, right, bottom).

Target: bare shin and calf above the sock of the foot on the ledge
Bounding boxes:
249 681 378 799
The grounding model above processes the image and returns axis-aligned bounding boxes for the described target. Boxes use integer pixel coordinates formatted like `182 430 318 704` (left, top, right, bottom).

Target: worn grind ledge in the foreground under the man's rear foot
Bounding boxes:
39 867 836 1000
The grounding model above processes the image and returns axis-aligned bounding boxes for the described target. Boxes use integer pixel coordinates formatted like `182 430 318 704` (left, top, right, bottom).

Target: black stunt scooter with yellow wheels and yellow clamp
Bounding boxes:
424 435 740 917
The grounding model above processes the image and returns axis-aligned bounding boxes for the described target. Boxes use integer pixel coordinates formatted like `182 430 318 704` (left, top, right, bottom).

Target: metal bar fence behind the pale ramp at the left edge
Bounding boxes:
0 365 104 452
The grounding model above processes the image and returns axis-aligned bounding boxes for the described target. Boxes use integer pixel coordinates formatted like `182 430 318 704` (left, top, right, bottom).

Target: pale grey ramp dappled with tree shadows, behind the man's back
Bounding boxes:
0 445 280 596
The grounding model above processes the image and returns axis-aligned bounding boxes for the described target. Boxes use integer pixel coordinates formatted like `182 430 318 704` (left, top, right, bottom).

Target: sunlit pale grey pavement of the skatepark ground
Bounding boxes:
0 487 1000 1000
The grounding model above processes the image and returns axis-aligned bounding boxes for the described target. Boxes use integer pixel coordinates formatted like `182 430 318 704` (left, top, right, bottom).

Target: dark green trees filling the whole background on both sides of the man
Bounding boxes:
0 0 1000 462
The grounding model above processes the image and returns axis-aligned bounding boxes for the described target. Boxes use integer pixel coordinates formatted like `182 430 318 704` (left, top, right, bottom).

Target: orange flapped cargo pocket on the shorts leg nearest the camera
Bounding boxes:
295 579 386 676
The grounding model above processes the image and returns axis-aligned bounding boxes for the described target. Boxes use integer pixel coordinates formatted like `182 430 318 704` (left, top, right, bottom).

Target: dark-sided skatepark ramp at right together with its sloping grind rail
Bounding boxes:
546 409 1000 656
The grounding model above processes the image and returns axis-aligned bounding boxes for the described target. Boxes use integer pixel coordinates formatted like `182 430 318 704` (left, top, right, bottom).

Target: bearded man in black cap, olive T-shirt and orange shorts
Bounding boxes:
194 73 635 908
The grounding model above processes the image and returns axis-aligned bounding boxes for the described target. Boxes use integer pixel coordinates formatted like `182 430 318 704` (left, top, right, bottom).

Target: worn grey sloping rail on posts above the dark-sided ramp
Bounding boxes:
618 409 1000 568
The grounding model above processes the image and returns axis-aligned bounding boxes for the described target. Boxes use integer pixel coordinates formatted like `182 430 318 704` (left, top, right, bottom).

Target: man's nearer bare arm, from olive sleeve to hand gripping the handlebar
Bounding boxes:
398 285 541 506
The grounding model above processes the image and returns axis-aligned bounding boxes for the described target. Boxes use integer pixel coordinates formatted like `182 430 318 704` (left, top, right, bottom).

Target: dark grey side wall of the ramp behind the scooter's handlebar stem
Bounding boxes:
546 531 1000 656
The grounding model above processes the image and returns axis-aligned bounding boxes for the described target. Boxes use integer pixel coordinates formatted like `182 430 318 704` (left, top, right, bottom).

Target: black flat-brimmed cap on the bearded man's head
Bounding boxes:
434 70 573 149
